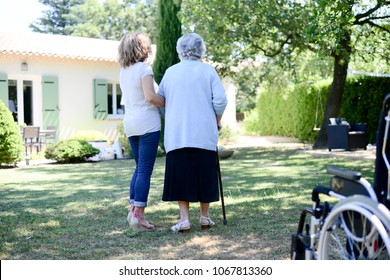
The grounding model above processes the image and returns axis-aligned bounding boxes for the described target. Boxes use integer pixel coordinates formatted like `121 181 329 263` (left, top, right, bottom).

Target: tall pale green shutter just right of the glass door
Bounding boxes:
42 76 59 130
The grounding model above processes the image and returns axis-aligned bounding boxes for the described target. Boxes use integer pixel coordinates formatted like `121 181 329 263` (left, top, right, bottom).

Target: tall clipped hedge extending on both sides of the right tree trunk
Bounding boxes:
244 76 390 143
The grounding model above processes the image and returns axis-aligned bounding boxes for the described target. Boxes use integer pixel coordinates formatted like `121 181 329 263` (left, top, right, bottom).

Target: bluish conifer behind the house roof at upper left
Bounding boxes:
30 0 85 35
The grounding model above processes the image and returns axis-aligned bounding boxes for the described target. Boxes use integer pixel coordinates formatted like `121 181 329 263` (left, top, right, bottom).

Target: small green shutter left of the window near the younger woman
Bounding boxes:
93 79 108 120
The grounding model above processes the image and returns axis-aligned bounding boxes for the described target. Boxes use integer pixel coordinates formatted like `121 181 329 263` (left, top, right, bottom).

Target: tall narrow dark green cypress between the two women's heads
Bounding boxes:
153 0 181 83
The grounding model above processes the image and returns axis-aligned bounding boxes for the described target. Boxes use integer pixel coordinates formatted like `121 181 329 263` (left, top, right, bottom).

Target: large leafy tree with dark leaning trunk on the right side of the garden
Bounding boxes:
181 0 390 148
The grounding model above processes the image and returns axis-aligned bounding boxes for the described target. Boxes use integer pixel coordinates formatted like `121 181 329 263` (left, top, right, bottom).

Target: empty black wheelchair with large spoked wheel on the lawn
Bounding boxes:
290 94 390 260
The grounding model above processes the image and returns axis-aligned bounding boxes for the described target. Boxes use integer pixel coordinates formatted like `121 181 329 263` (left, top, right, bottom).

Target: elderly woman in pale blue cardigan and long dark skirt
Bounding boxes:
158 33 227 232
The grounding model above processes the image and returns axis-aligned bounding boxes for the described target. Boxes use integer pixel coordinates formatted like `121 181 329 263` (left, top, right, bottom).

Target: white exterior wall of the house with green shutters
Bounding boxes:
0 56 122 139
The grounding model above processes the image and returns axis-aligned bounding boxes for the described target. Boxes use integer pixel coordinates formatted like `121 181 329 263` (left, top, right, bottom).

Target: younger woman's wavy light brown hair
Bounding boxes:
118 32 152 67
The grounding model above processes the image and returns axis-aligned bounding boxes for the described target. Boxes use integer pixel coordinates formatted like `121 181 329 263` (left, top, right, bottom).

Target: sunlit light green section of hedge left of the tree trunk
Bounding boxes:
244 80 330 142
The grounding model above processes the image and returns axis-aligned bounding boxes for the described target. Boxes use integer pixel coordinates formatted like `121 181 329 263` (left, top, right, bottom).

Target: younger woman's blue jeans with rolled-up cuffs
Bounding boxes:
129 131 160 207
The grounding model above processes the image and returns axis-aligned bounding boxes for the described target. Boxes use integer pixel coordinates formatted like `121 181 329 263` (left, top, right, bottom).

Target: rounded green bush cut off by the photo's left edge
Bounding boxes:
0 100 24 165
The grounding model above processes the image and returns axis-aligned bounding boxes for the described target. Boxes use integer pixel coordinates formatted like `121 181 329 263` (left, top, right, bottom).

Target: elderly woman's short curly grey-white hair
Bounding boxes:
176 33 206 60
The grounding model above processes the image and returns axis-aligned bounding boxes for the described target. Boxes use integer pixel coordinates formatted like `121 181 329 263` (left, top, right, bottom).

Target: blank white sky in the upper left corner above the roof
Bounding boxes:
0 0 46 32
